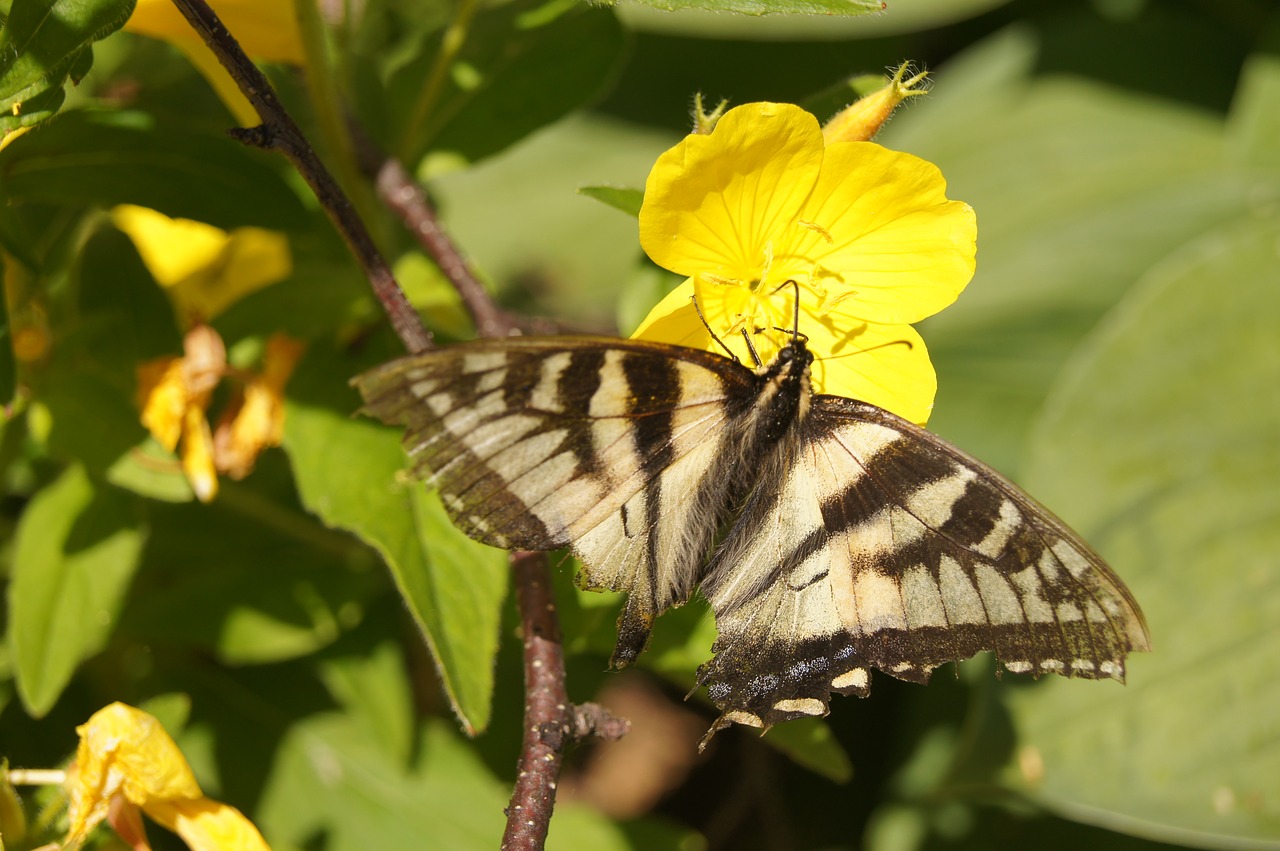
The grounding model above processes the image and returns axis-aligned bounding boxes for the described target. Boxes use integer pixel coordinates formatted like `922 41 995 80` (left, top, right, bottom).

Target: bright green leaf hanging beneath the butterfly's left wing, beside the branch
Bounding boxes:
284 342 508 733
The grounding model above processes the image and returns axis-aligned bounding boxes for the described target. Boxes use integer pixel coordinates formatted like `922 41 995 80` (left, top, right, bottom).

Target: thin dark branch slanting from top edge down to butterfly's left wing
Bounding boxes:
173 0 431 352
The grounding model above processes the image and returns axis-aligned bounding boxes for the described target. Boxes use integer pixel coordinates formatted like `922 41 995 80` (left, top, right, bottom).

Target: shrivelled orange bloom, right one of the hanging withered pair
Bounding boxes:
214 334 303 479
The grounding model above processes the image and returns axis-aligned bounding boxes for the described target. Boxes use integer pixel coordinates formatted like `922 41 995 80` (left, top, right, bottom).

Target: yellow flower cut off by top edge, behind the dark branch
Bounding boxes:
124 0 303 127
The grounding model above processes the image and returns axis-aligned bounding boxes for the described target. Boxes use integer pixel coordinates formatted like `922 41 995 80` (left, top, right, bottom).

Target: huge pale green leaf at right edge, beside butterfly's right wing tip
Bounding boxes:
1007 216 1280 848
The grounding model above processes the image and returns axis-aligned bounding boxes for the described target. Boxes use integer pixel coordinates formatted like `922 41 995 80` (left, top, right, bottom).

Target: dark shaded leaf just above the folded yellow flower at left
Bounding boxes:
0 109 306 229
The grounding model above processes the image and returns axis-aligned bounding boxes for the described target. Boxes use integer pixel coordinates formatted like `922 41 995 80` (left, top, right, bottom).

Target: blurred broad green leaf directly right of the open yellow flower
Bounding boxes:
878 29 1258 473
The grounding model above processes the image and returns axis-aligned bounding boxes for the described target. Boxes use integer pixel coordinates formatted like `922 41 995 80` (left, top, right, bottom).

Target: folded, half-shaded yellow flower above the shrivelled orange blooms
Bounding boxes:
111 205 293 322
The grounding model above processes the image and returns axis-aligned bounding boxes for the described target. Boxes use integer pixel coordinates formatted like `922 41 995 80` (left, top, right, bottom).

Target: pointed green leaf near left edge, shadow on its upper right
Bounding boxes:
9 466 146 718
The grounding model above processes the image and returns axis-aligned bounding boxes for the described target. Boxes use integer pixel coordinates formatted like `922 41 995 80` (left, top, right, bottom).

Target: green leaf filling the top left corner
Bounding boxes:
0 0 134 136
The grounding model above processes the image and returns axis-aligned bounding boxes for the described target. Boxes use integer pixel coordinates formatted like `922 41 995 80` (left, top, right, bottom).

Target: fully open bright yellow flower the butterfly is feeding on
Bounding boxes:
635 104 977 424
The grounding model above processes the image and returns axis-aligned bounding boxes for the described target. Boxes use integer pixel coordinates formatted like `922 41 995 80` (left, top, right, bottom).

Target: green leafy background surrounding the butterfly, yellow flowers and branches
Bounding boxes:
0 0 1280 851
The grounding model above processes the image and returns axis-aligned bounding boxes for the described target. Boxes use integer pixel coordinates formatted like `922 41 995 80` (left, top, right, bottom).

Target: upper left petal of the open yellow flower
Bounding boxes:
640 104 822 284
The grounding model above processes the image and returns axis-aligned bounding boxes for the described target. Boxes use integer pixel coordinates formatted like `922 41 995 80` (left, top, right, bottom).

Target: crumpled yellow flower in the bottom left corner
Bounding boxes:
63 703 270 851
